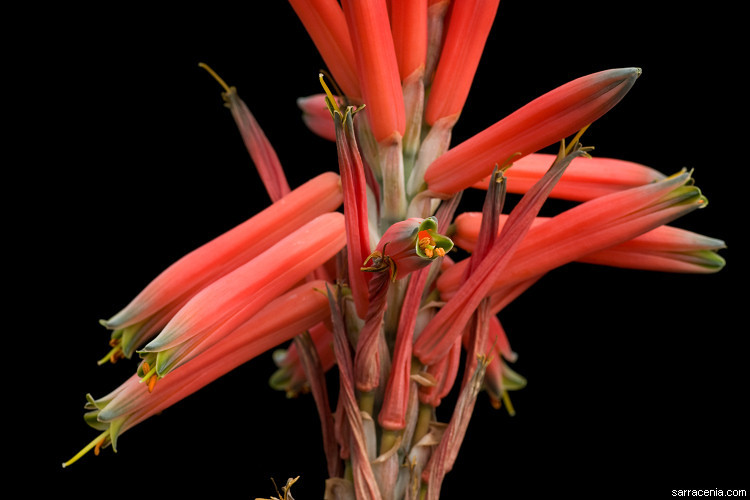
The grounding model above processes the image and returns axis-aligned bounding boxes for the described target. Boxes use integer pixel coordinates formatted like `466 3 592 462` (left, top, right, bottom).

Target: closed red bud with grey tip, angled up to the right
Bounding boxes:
424 68 641 197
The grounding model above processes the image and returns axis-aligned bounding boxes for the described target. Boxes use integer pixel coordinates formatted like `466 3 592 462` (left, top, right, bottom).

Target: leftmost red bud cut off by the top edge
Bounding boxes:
289 0 362 101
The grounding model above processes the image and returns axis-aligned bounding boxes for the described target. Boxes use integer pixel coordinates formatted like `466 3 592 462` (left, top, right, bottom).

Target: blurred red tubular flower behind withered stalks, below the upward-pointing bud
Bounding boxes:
473 153 666 201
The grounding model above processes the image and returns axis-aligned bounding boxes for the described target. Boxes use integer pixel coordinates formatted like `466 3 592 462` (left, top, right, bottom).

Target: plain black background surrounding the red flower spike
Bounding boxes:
19 0 748 499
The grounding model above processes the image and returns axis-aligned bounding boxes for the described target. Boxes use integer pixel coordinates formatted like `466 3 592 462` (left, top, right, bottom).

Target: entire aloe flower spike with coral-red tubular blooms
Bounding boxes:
66 0 725 500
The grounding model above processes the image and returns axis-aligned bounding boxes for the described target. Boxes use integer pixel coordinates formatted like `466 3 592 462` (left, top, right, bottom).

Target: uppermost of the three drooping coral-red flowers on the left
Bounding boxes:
102 172 343 358
